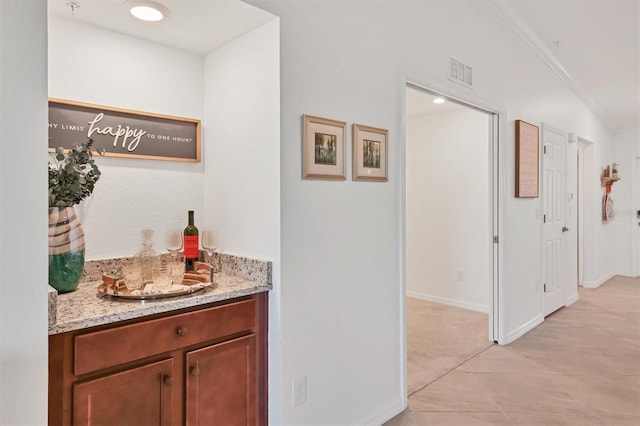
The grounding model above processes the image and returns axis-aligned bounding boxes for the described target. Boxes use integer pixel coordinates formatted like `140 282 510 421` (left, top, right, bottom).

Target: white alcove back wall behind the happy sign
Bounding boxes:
49 16 209 260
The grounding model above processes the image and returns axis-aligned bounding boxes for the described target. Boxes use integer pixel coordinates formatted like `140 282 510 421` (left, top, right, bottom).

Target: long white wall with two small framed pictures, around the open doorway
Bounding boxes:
244 0 611 425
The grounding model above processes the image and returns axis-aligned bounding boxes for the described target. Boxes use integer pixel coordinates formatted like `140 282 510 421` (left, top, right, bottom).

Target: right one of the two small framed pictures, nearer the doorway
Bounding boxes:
353 124 389 182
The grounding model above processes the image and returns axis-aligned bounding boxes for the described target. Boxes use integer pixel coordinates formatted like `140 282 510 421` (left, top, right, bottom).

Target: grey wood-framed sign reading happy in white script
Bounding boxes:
49 98 200 163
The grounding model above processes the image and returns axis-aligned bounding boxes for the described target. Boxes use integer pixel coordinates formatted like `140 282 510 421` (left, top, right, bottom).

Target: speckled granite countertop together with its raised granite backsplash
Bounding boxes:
49 253 272 334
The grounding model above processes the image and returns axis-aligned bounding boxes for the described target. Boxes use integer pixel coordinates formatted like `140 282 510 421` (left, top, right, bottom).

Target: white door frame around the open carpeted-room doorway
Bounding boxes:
398 76 508 348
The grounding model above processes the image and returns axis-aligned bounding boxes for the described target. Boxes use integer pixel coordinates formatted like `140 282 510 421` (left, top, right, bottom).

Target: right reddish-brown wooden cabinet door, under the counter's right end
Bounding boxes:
186 334 258 426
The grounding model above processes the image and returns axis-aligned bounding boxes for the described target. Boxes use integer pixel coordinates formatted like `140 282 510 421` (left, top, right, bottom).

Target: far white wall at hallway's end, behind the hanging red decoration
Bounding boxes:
608 129 640 277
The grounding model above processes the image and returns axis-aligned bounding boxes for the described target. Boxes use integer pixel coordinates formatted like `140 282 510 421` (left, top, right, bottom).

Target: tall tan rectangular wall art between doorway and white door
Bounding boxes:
515 120 540 198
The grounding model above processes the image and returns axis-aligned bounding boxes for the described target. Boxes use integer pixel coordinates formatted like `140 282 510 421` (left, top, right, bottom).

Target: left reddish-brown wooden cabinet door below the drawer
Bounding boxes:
73 359 174 426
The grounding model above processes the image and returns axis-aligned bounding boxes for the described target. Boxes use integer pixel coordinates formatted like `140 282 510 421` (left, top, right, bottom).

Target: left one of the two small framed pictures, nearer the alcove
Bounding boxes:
302 115 347 180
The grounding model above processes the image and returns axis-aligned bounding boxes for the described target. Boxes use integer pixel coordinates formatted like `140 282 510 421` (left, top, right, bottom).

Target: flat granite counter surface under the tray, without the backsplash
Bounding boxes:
49 274 271 334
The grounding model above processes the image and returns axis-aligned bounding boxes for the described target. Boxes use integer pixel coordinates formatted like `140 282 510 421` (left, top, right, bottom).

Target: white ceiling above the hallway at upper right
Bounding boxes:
487 0 640 131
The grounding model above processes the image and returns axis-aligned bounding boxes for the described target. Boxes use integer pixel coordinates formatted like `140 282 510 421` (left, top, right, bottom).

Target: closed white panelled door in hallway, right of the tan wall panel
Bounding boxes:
542 125 568 316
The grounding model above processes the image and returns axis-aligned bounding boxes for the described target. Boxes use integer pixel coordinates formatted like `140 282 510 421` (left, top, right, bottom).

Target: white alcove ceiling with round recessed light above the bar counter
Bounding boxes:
48 0 275 55
